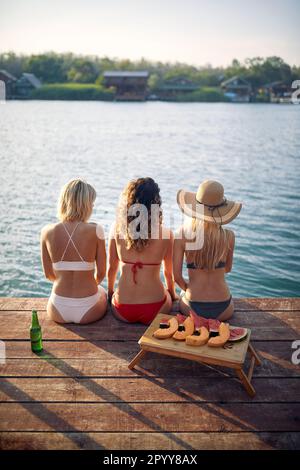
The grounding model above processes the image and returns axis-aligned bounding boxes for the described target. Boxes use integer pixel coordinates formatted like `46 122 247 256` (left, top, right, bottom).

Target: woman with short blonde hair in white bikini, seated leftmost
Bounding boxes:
41 179 107 324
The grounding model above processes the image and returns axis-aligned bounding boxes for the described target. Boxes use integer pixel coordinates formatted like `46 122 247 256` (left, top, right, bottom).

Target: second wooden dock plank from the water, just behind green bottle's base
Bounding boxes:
0 311 300 341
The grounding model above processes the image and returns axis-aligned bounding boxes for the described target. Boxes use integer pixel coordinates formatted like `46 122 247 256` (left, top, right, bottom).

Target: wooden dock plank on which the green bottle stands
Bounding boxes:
0 341 300 378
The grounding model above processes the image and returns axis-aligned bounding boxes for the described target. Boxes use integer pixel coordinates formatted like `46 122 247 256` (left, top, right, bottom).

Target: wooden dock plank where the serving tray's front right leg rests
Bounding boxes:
0 375 300 403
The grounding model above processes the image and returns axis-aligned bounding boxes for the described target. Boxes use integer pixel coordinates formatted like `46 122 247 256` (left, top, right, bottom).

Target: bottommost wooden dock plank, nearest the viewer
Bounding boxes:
0 431 300 450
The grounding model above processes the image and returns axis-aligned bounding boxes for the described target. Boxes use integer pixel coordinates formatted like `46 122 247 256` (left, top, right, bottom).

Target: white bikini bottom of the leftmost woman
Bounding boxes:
48 286 105 323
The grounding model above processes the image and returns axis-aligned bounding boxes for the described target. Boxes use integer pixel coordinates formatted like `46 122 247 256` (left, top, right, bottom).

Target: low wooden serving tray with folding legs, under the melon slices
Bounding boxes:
128 313 261 396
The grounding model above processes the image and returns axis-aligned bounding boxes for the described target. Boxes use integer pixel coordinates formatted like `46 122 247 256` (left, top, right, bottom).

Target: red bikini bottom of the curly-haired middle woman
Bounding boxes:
113 296 167 325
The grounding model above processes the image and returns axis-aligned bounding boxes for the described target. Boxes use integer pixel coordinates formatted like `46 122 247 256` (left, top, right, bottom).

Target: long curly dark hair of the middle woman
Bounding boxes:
117 177 162 251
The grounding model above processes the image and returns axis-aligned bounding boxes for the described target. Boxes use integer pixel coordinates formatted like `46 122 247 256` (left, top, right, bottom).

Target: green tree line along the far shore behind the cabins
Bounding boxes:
0 52 300 89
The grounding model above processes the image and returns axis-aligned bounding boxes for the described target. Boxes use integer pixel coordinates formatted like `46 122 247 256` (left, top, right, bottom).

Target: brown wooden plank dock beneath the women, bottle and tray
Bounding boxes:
0 298 300 450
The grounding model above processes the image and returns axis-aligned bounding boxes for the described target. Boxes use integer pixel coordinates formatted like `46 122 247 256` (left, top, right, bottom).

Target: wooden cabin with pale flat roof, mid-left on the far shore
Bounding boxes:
103 70 149 101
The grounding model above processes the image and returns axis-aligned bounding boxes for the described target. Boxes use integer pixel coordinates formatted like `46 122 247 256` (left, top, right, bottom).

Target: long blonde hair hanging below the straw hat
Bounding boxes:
185 218 230 270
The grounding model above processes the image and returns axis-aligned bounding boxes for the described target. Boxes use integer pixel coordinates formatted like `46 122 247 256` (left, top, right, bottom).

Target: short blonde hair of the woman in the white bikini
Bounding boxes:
57 178 96 222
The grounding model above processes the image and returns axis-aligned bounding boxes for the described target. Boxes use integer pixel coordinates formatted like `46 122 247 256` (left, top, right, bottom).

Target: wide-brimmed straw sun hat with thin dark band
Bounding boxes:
177 180 242 225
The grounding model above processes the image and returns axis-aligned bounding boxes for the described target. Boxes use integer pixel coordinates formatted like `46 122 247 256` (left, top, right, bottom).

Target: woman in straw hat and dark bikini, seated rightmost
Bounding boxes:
173 180 242 321
